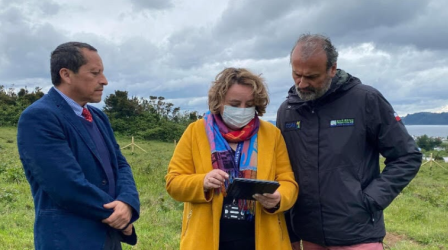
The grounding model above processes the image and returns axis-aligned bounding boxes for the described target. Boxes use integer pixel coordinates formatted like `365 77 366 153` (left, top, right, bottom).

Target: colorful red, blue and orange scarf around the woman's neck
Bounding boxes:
204 111 260 219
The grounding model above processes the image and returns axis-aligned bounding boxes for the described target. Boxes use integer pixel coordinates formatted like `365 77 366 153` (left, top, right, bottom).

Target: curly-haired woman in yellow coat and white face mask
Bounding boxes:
165 68 298 250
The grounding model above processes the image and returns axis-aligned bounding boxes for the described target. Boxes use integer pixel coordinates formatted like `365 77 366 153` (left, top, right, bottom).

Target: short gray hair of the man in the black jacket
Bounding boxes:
289 34 339 70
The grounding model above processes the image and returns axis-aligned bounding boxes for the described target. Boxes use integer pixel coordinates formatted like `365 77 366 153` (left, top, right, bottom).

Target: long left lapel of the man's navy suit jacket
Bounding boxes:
48 88 102 165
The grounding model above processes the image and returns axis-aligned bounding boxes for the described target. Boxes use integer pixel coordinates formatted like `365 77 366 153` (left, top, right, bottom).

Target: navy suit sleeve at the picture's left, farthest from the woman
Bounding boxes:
17 108 113 220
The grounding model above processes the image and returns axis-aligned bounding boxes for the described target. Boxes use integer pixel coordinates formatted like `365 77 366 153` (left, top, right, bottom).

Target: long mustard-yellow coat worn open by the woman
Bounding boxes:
165 119 299 250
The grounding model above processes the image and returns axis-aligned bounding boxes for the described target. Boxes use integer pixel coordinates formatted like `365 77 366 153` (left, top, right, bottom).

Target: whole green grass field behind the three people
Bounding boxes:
0 127 448 250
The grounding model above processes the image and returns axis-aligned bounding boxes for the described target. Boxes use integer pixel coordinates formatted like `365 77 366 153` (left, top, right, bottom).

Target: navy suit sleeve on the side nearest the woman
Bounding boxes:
96 109 140 223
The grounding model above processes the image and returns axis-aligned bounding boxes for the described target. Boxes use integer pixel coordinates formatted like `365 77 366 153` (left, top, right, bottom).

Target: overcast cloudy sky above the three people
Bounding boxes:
0 0 448 120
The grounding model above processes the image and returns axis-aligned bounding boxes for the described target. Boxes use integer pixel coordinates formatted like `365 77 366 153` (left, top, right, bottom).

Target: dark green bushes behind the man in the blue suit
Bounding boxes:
0 85 202 141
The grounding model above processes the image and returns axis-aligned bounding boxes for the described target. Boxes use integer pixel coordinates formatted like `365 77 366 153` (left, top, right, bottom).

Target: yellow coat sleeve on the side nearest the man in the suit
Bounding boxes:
165 120 214 203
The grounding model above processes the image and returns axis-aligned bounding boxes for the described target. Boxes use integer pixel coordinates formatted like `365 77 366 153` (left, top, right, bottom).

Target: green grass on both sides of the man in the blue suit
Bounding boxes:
0 127 183 250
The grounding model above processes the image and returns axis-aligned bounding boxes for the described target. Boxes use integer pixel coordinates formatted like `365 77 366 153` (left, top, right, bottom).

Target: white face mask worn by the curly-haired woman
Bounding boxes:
222 105 255 128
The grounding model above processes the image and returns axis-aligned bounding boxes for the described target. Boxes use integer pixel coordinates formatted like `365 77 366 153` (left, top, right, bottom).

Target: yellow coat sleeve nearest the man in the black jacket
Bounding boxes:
265 128 299 213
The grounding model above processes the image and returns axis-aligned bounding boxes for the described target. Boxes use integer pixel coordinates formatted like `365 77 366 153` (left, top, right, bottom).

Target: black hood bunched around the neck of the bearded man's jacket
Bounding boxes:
286 69 361 106
